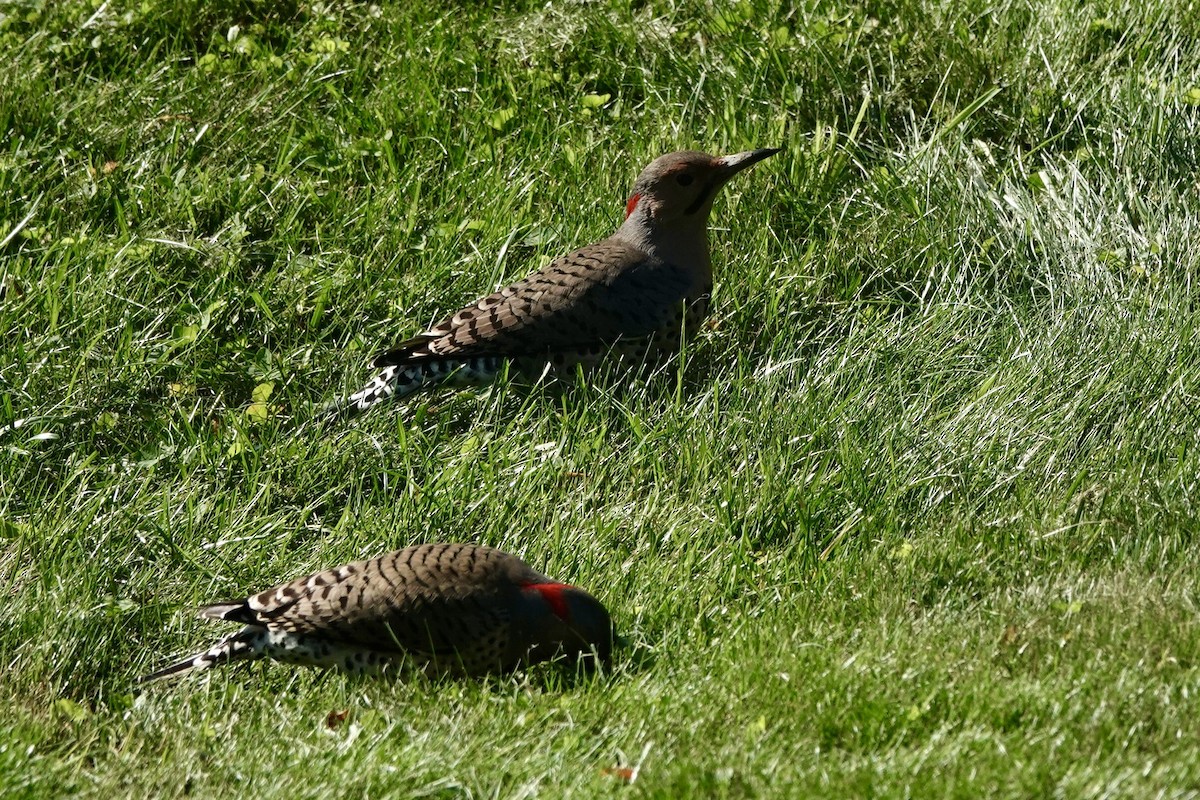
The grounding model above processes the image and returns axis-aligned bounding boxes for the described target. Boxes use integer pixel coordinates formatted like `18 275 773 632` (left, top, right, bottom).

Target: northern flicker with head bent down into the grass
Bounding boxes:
142 543 612 681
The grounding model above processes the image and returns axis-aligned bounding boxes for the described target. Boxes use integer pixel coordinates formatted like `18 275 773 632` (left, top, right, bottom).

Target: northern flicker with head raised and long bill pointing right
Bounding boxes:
326 149 779 414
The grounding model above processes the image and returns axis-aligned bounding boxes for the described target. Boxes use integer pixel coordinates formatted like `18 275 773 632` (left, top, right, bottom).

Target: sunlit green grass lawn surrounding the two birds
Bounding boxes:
0 0 1200 798
